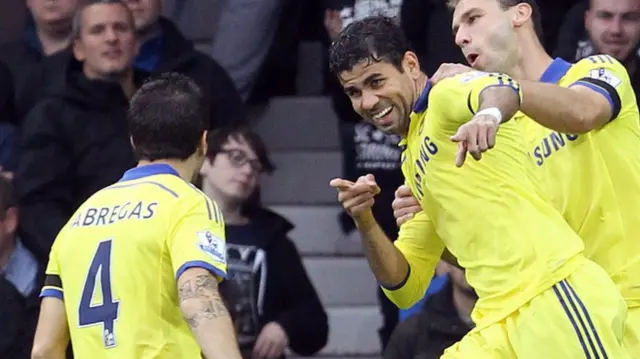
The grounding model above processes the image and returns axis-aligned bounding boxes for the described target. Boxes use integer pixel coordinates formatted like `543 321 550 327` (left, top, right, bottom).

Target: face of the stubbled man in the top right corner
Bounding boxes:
585 0 640 61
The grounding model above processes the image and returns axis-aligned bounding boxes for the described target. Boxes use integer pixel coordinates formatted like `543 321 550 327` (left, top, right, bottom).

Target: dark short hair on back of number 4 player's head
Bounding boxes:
129 73 207 161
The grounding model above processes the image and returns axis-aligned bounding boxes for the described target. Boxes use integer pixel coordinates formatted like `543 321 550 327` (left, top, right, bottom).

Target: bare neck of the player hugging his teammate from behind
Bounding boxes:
504 33 553 81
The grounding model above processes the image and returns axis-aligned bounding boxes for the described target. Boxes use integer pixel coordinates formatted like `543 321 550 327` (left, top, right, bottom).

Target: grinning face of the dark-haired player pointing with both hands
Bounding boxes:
338 52 422 136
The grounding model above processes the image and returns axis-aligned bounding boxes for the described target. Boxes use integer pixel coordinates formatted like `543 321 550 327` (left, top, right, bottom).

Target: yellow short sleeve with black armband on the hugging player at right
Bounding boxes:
569 55 636 119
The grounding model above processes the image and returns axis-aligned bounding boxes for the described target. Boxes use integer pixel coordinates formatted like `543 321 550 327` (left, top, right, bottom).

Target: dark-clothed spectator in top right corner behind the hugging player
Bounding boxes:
554 0 640 100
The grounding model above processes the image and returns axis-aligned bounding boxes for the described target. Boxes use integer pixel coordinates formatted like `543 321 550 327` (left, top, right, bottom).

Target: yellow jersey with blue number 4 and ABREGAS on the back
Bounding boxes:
41 164 226 359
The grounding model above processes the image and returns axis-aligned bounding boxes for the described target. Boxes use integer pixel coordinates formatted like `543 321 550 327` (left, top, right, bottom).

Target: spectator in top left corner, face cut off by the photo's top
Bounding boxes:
0 0 84 120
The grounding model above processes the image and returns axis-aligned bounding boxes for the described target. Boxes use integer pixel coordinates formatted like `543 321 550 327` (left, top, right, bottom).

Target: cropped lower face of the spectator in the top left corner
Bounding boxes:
27 0 84 29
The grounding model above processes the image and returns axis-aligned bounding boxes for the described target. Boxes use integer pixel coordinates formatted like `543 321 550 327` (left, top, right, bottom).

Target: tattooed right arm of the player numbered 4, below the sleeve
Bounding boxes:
178 273 242 359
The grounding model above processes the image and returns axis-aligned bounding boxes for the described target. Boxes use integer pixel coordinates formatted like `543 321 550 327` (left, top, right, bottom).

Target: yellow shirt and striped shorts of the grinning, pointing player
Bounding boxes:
386 72 626 359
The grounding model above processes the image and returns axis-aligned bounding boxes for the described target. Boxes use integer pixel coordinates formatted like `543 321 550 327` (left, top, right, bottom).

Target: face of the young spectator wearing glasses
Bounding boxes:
200 136 263 207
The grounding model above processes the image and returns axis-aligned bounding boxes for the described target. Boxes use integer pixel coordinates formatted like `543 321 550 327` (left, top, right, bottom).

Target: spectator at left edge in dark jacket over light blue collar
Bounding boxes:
0 177 43 359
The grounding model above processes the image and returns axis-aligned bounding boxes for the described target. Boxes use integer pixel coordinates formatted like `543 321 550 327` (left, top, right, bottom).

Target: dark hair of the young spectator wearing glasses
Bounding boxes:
207 126 276 174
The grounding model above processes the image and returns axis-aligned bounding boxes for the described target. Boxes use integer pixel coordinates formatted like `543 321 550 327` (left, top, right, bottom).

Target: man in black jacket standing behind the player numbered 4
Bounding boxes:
16 0 143 263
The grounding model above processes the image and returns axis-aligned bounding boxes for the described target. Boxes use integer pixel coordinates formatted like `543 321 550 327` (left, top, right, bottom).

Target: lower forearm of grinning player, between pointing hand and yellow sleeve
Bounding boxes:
355 214 409 288
